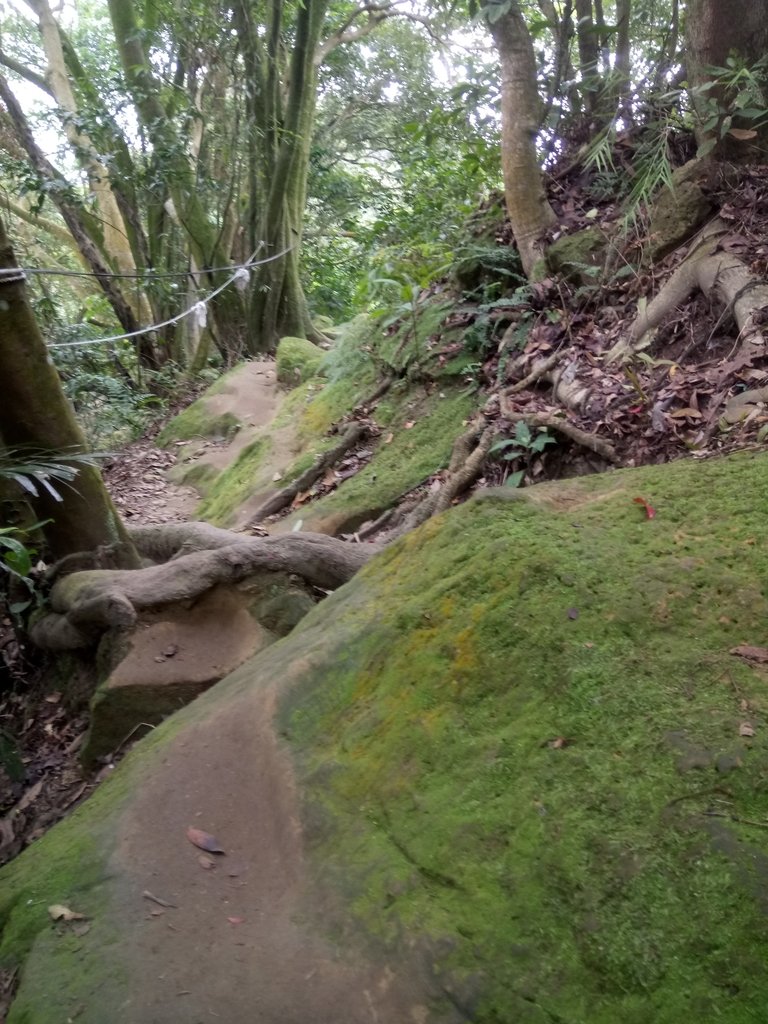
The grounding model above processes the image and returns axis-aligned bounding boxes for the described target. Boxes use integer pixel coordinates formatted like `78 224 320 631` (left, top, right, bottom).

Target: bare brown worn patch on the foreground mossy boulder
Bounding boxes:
102 684 438 1024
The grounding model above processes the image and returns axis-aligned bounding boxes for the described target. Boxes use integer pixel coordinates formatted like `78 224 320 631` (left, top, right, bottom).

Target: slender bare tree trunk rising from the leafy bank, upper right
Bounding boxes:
489 0 555 278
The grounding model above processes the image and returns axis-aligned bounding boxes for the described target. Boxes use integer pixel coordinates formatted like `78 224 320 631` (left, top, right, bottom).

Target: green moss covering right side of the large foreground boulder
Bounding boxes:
284 456 768 1024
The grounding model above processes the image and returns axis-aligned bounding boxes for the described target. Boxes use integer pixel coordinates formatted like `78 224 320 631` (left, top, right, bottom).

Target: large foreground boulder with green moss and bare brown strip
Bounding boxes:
0 454 768 1024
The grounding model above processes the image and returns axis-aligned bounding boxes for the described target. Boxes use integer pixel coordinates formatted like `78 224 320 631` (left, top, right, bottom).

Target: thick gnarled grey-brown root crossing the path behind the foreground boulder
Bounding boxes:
30 523 379 650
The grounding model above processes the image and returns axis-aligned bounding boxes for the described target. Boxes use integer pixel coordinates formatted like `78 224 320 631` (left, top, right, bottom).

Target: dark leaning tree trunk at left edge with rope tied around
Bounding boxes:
0 218 138 568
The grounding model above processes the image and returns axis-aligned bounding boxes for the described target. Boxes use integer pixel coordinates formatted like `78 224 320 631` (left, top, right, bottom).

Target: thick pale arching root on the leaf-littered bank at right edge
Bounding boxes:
606 217 768 362
